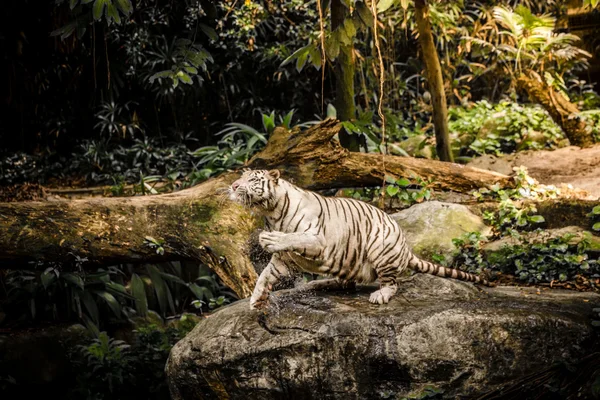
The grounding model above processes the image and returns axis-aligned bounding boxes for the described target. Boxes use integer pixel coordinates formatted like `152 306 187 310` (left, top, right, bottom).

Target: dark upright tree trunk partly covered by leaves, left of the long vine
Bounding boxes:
331 0 360 151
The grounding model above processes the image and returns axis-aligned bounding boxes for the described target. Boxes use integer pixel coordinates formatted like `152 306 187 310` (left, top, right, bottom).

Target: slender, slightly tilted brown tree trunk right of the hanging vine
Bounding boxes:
415 0 454 162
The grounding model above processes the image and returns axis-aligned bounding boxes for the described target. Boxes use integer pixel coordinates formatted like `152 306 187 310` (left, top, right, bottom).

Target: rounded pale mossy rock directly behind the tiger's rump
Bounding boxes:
392 201 491 262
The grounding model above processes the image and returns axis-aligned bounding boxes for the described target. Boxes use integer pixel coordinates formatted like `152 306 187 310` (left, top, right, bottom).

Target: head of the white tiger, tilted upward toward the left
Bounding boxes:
229 169 280 208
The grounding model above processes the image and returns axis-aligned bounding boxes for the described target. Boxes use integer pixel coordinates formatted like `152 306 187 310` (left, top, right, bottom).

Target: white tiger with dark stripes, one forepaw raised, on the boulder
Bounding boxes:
229 170 493 309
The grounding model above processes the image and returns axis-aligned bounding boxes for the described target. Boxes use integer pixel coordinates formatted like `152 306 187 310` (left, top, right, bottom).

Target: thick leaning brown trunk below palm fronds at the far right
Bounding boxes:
517 75 594 147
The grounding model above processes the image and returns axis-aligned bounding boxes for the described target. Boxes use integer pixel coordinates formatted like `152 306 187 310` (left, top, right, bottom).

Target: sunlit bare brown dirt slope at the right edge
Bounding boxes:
468 144 600 199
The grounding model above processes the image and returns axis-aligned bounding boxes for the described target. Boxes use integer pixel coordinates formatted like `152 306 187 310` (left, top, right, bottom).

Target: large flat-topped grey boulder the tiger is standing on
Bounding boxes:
166 274 600 400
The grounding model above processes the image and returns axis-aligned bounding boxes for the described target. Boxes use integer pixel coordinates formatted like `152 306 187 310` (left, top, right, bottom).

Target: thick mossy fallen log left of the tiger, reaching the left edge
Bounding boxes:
0 174 257 297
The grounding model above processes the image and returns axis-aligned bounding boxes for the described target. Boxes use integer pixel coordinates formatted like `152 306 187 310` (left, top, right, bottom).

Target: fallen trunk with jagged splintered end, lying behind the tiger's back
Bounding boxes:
249 120 511 192
